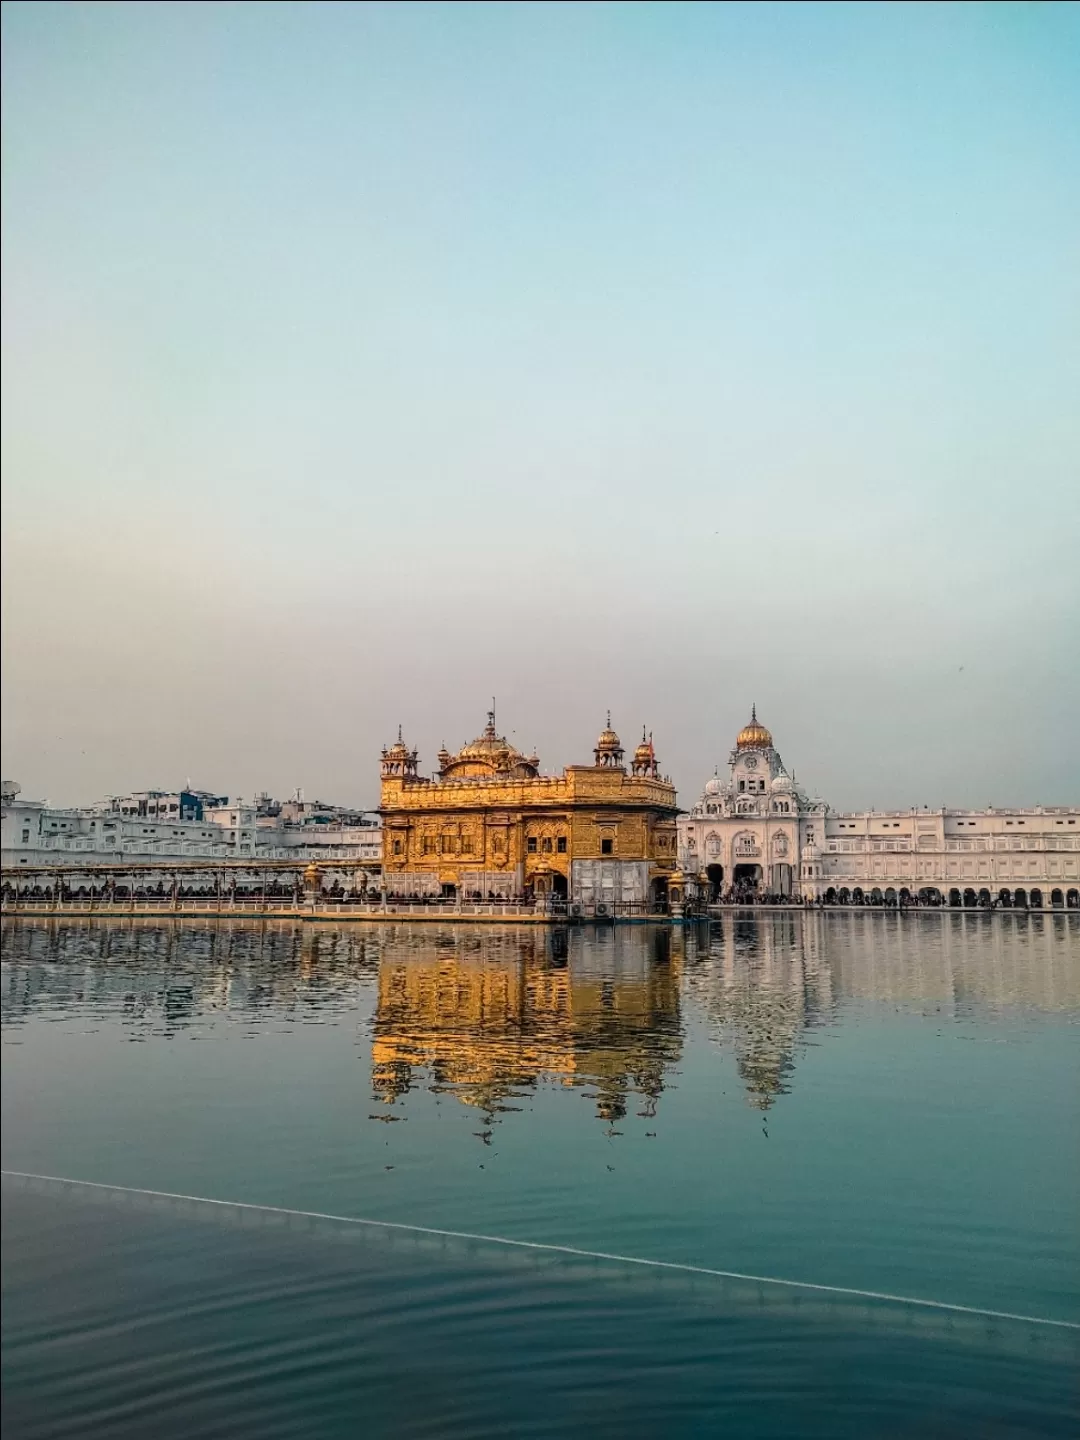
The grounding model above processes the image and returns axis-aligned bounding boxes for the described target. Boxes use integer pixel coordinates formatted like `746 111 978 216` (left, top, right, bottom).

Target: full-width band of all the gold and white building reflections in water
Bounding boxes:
1 910 1080 1122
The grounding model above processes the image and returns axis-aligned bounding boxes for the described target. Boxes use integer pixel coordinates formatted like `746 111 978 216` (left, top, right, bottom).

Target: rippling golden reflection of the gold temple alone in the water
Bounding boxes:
372 927 683 1120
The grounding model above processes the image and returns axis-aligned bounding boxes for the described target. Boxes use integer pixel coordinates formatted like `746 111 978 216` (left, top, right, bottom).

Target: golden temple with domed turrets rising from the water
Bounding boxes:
379 710 678 909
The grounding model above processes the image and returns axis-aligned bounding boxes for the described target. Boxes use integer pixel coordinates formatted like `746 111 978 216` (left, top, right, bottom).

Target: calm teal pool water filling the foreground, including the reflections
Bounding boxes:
3 913 1080 1436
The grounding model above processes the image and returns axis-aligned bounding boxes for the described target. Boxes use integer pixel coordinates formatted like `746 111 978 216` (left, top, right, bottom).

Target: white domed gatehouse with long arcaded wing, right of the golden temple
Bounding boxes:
678 710 1080 909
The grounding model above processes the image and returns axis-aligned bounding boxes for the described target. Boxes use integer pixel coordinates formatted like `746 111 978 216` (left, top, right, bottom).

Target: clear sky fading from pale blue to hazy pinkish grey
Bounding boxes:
3 3 1080 808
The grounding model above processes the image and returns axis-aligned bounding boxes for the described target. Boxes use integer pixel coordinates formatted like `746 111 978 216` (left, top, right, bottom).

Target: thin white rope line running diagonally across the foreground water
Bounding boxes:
0 1169 1080 1331
